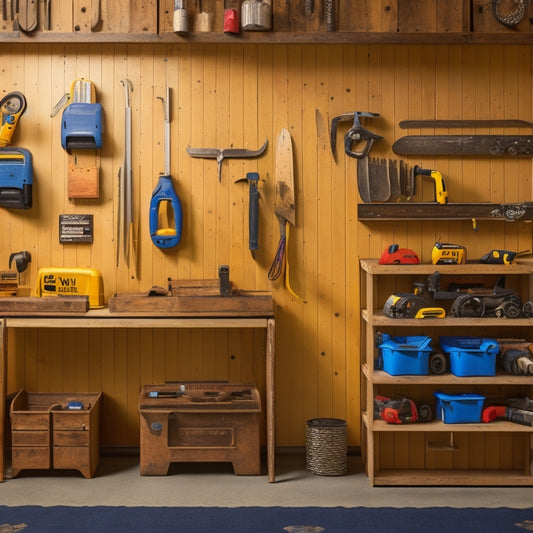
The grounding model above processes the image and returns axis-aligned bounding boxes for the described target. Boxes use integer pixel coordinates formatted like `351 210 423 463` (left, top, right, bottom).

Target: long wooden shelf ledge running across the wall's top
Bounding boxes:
0 31 533 45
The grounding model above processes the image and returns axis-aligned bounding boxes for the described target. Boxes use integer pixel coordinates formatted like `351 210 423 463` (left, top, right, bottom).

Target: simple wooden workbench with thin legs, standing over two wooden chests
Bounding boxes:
0 309 275 482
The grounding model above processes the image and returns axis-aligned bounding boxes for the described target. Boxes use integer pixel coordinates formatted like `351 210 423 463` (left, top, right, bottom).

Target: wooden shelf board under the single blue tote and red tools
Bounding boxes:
363 412 533 434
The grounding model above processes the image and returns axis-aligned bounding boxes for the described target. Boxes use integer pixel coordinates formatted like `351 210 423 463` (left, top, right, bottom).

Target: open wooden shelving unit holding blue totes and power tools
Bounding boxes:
360 259 533 486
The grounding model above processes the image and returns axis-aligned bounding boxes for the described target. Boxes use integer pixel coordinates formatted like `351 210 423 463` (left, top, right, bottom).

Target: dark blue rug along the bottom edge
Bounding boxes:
0 506 533 533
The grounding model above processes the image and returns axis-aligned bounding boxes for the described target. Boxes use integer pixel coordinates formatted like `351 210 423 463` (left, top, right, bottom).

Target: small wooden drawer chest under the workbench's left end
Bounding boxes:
10 389 102 478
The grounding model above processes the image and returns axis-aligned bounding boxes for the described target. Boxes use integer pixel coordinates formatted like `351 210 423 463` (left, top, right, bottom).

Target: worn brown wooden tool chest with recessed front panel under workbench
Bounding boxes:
139 382 261 476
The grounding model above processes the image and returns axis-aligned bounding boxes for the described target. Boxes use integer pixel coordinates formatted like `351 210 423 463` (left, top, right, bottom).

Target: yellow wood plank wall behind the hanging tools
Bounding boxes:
4 44 533 446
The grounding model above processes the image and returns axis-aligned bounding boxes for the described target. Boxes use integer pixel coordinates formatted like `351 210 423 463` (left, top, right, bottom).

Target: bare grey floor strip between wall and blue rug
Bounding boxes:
0 453 533 508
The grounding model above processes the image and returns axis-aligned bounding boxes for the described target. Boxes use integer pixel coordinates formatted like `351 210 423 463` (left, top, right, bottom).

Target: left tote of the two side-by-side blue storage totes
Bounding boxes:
379 333 431 376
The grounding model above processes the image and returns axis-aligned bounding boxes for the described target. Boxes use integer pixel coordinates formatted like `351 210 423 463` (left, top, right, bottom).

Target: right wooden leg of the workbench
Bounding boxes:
266 318 276 483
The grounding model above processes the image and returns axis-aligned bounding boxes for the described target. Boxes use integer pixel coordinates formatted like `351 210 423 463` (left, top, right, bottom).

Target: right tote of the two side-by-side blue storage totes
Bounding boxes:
439 336 500 377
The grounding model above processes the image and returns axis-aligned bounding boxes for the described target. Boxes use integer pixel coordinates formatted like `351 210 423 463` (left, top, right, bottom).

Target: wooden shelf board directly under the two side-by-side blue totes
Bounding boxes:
362 363 533 386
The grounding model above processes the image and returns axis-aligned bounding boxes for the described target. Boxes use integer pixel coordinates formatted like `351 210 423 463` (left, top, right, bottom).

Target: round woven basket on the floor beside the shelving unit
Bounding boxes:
305 418 347 476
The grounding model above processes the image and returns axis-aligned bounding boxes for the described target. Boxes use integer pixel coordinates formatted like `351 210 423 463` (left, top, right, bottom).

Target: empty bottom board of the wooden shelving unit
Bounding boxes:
374 469 533 487
